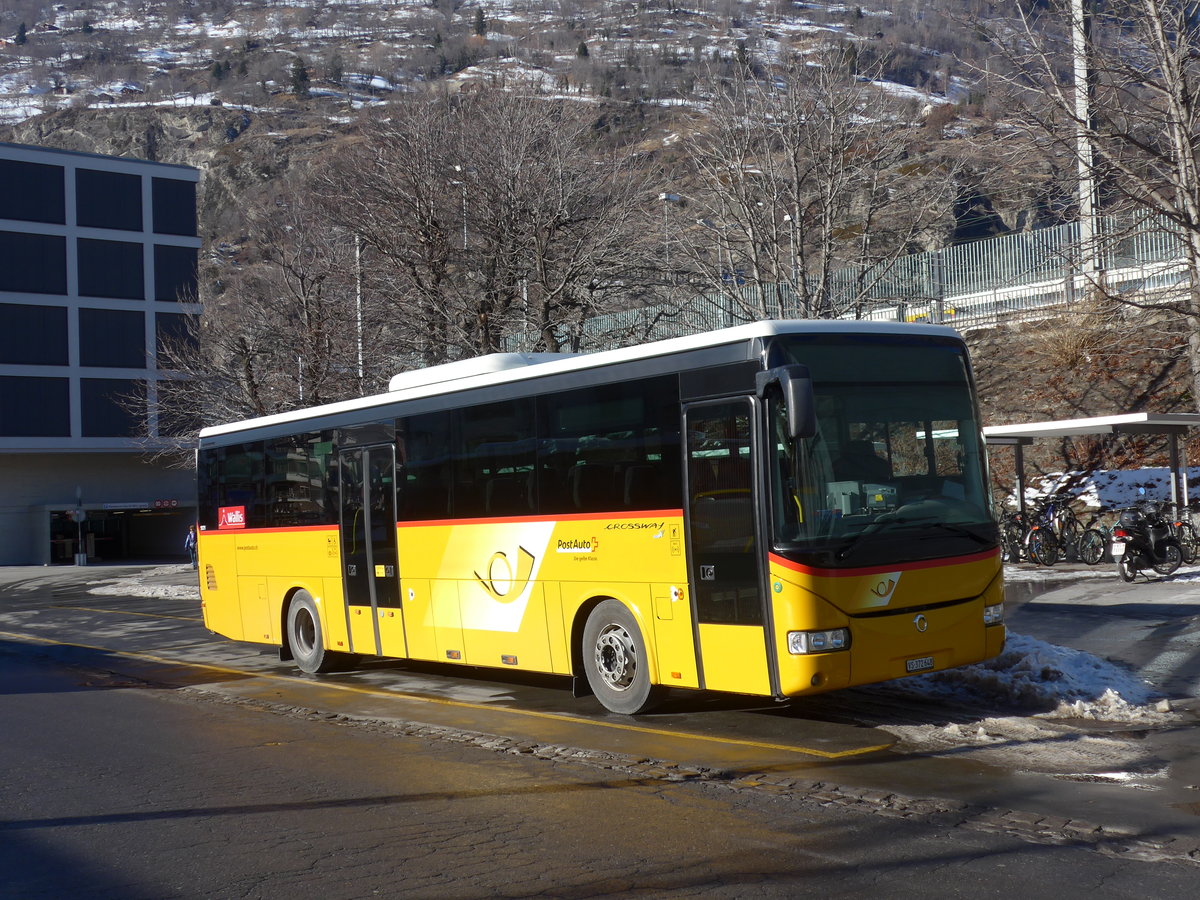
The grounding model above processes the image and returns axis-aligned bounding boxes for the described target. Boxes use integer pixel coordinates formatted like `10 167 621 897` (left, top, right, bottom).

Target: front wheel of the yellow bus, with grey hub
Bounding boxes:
582 600 659 715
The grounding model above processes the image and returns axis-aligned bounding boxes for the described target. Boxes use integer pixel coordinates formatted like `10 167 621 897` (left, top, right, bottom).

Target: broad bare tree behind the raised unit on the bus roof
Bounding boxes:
322 89 649 364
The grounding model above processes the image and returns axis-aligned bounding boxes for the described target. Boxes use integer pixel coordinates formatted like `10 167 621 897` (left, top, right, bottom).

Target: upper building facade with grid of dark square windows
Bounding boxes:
0 142 199 452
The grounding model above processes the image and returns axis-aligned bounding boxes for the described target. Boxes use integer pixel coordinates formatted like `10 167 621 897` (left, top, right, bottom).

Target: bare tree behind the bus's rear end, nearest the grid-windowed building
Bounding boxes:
158 178 395 437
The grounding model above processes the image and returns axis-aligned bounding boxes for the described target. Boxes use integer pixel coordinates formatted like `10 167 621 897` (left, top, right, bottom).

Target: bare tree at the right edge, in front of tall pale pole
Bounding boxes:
978 0 1200 404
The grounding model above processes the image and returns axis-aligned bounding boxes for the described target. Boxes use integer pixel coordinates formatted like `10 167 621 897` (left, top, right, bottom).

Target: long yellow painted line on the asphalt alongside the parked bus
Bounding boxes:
0 631 892 760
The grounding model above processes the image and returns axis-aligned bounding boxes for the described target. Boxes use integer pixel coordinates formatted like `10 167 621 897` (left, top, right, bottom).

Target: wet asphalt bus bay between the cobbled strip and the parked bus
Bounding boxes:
0 566 1200 860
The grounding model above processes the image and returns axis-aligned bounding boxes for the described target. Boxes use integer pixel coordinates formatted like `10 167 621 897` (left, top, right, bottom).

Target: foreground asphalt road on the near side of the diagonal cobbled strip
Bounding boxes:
0 644 1195 900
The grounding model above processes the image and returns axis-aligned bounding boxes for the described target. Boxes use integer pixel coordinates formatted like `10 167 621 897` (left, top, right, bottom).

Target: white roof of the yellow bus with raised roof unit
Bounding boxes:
200 319 959 439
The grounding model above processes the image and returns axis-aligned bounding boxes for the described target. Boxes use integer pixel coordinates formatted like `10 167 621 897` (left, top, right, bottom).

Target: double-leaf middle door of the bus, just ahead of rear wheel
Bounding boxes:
338 444 407 656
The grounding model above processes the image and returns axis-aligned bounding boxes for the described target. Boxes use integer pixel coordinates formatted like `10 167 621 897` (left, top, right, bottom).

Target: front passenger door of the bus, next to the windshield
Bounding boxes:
684 398 772 694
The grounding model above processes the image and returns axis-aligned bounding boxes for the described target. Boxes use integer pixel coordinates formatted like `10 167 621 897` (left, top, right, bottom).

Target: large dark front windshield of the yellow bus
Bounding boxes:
767 334 996 569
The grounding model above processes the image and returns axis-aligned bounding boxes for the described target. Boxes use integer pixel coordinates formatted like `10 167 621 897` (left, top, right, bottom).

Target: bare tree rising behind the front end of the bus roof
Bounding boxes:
668 43 953 318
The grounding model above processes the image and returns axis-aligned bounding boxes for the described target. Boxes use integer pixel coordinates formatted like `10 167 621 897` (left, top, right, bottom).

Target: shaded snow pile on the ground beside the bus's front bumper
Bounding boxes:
889 632 1169 722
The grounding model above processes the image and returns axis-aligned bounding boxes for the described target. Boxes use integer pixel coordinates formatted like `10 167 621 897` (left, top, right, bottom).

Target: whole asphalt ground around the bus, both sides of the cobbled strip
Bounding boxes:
0 570 1200 898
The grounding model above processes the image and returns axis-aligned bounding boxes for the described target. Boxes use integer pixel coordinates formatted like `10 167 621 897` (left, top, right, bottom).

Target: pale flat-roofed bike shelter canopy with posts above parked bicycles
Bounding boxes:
983 413 1200 512
